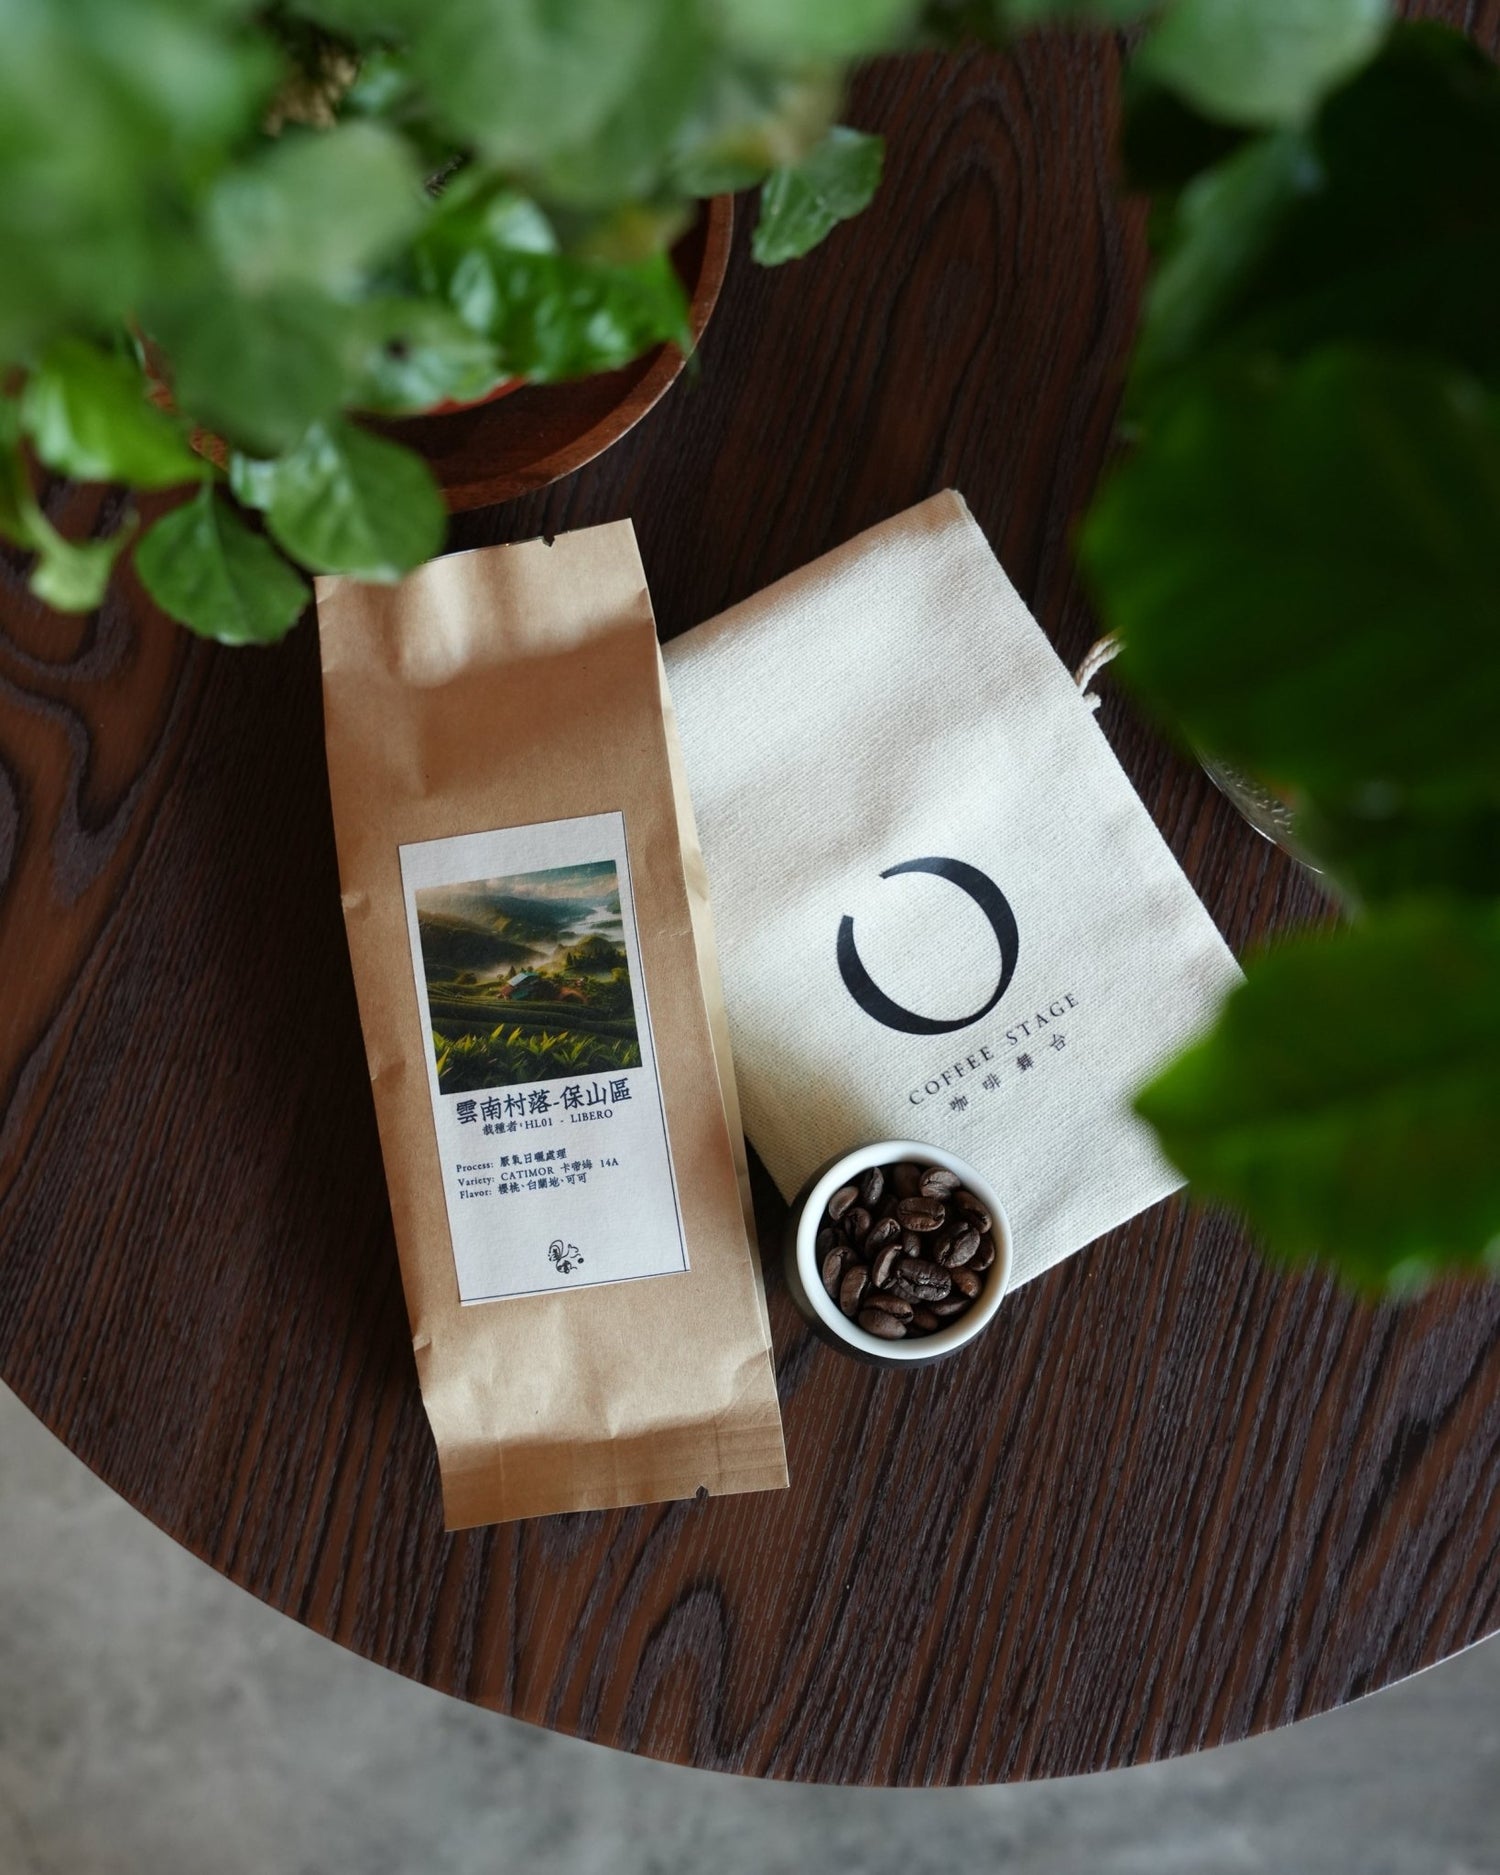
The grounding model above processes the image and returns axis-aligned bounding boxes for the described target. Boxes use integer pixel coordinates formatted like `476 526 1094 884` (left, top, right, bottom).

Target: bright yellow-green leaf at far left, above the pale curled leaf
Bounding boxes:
21 338 210 488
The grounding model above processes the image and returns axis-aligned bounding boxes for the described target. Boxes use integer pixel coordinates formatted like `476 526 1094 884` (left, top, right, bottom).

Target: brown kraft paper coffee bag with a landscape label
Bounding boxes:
317 521 786 1528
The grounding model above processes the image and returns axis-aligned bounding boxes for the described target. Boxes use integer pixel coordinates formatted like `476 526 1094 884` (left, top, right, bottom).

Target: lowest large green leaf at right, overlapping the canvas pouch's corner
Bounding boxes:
1136 906 1500 1286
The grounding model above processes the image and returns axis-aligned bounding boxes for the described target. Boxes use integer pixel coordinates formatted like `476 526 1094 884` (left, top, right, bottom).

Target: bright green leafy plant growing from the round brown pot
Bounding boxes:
0 0 879 643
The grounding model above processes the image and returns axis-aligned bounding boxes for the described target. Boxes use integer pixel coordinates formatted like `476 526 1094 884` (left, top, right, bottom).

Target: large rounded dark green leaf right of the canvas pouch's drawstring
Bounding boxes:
1082 353 1500 797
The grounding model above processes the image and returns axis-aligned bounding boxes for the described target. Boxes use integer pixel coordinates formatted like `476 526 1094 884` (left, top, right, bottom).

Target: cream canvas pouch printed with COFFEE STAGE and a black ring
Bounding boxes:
666 493 1238 1281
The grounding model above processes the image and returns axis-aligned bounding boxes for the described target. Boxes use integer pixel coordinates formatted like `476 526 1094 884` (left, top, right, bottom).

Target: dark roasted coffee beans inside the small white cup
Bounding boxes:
818 1161 996 1341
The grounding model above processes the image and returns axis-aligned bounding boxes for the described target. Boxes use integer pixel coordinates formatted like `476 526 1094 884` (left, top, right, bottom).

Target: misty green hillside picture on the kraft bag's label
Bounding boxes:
416 861 641 1093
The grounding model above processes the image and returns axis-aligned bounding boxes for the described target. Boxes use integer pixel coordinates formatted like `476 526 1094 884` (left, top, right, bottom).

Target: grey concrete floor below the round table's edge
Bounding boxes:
0 1388 1500 1875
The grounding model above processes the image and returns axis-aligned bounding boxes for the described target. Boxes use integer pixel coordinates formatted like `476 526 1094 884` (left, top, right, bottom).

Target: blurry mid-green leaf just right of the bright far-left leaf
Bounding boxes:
148 285 356 452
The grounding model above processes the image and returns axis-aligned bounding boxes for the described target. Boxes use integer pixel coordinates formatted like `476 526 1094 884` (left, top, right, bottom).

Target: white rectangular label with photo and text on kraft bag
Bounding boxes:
401 814 688 1301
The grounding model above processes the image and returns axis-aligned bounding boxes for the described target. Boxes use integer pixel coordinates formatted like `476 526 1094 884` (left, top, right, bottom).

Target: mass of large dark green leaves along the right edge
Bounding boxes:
1082 22 1500 1286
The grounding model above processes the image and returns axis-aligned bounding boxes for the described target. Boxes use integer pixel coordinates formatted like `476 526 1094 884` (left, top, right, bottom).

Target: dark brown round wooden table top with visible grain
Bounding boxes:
0 4 1500 1783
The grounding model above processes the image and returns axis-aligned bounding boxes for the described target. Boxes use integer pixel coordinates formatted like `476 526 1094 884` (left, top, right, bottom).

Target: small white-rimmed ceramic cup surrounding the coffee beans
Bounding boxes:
786 1140 1014 1367
